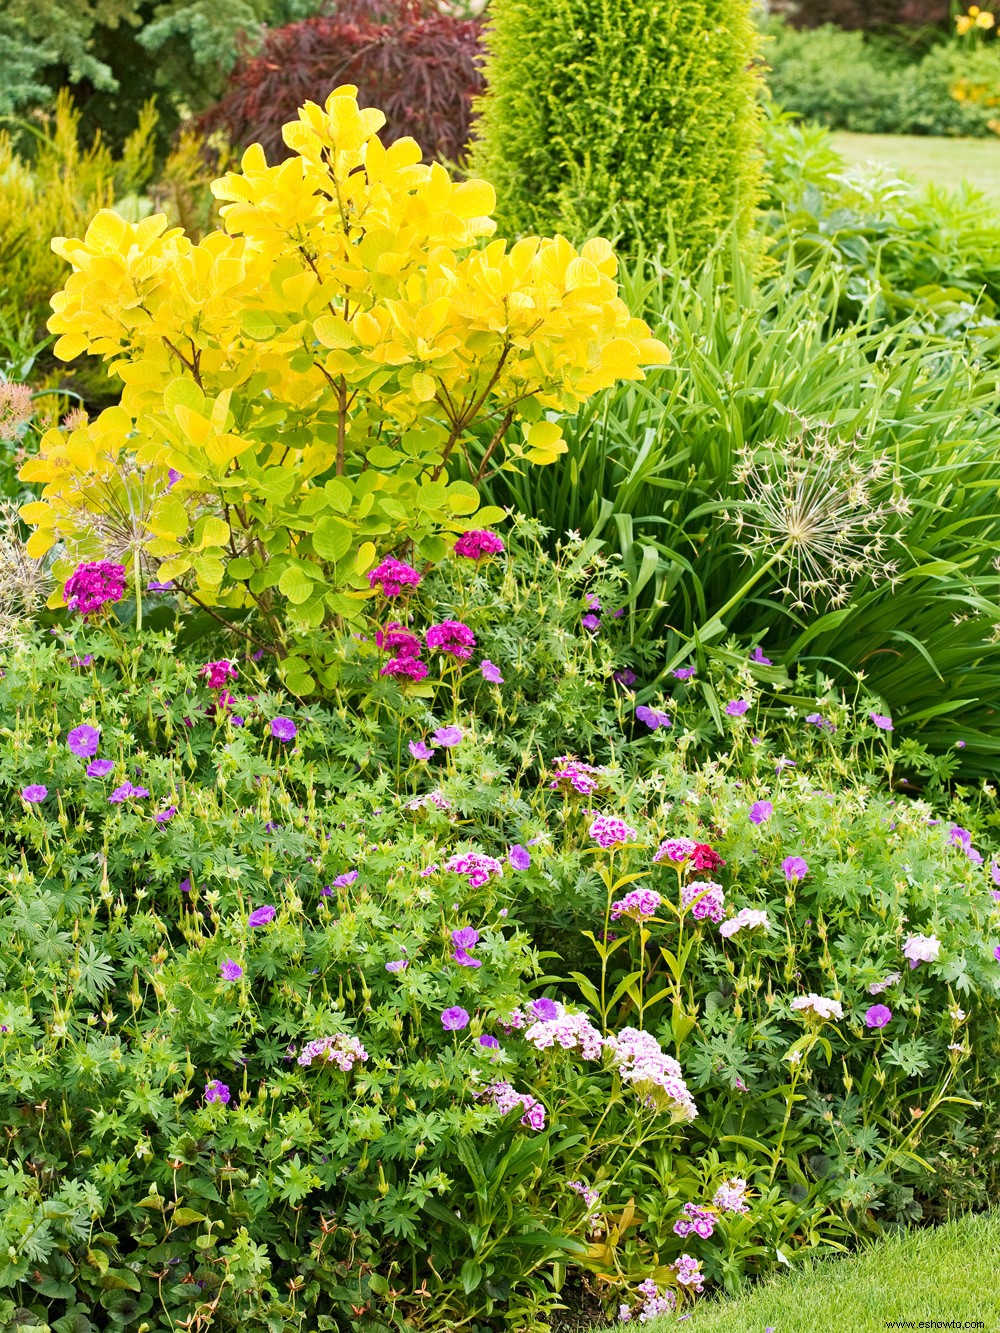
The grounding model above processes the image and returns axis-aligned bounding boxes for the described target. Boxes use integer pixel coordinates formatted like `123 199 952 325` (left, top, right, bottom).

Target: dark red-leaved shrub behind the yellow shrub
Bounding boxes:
199 0 483 161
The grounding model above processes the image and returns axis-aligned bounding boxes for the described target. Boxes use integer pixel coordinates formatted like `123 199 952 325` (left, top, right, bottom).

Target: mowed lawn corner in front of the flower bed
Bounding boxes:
643 1213 1000 1333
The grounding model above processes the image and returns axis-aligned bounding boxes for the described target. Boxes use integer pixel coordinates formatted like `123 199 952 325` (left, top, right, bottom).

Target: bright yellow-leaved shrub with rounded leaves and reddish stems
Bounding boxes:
21 87 668 690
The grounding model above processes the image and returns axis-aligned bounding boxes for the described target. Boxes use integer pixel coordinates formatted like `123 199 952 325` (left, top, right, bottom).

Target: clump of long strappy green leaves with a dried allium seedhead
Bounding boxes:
474 247 1000 766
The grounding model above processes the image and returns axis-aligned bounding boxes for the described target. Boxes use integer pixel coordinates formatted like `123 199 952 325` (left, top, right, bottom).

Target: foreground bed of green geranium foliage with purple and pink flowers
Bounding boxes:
0 527 1000 1330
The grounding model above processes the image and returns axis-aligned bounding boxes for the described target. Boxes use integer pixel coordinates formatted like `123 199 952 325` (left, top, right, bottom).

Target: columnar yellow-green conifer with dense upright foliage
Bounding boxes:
473 0 759 261
